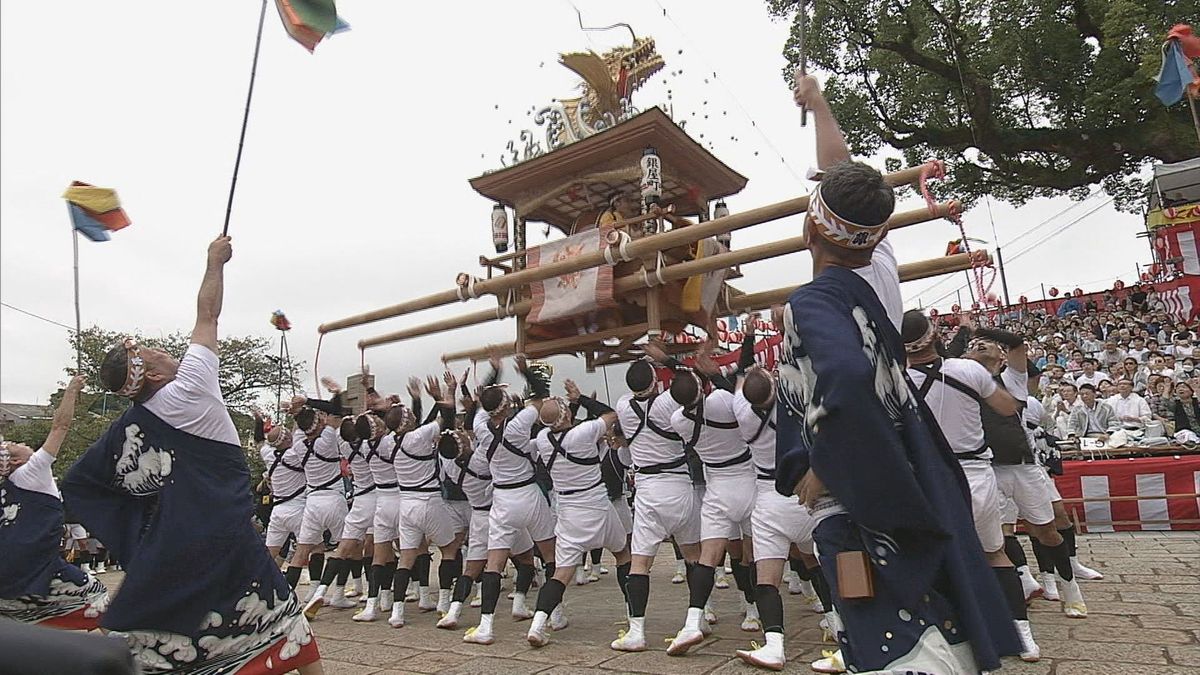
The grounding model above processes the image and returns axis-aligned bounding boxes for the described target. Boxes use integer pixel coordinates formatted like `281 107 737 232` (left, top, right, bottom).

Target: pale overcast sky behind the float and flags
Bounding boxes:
0 0 1148 402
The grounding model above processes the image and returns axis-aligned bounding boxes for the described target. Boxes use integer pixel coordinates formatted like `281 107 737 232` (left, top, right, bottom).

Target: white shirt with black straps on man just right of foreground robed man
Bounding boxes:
908 359 997 459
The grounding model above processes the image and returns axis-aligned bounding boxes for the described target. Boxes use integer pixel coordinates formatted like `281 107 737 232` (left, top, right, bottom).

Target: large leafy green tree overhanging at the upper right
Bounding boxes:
767 0 1200 210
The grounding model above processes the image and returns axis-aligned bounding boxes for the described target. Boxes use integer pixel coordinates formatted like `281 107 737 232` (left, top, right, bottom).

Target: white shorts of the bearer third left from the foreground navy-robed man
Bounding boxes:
630 473 700 556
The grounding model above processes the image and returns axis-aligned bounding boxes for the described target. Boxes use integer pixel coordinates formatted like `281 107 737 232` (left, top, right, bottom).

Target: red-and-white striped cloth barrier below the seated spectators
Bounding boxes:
1055 455 1200 532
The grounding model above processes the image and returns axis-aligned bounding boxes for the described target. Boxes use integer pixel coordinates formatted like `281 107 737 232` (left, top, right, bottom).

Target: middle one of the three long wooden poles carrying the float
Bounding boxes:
359 202 959 350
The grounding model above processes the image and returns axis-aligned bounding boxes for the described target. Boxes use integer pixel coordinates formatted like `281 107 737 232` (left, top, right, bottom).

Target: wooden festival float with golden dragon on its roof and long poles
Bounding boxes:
319 37 989 371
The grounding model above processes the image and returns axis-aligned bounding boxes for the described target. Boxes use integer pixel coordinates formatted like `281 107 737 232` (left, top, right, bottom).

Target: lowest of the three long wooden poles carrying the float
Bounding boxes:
442 253 977 362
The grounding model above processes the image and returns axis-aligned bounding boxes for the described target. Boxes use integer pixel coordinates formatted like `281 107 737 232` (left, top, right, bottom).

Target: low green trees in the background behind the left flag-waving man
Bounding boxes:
5 325 304 478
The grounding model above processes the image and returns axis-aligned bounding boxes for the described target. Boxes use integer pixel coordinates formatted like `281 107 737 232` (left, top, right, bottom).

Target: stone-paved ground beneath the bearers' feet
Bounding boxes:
300 532 1200 675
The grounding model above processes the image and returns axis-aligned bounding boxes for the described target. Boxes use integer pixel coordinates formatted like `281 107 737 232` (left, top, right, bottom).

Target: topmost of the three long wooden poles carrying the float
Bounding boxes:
317 165 928 333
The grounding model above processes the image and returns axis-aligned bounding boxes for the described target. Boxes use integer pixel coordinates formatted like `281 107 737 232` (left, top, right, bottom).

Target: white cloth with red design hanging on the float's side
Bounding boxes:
526 229 617 323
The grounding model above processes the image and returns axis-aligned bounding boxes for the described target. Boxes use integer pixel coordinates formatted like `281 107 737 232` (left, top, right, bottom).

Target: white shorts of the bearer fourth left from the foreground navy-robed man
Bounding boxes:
554 485 625 566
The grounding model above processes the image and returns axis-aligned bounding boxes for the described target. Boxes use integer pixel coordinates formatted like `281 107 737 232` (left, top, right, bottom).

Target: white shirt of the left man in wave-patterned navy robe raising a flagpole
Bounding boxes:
144 342 241 446
